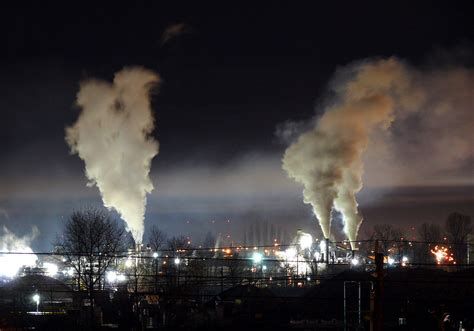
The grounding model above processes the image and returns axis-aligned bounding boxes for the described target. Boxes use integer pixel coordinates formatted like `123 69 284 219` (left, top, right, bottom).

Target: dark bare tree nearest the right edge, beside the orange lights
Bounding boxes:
446 213 472 263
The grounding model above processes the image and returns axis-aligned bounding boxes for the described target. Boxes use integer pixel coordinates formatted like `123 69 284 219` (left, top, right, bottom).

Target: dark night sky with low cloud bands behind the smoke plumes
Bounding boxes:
0 1 474 249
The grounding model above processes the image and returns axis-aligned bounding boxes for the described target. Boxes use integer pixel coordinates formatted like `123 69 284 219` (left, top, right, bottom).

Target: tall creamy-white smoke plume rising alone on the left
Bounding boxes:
66 67 160 242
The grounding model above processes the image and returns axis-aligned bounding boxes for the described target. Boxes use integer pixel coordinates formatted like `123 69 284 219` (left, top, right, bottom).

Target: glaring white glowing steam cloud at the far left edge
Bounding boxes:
0 226 39 278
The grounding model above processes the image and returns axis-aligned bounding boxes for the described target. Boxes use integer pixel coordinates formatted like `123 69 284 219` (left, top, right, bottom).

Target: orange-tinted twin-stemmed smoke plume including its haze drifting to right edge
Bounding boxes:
283 58 474 249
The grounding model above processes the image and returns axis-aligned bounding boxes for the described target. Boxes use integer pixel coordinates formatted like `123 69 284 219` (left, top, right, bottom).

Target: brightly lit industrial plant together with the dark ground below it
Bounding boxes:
0 220 474 330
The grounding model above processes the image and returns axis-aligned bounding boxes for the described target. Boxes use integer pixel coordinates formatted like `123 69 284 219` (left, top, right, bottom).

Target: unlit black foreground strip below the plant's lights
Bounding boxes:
0 268 474 331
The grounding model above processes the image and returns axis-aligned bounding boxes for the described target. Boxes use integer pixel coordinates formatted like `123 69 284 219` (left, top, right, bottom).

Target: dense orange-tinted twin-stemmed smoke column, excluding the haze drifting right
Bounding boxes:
283 59 409 245
